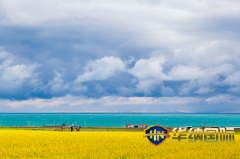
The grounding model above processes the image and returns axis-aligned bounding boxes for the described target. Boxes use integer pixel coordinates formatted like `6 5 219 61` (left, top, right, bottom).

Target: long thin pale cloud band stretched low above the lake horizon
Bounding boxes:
0 95 202 109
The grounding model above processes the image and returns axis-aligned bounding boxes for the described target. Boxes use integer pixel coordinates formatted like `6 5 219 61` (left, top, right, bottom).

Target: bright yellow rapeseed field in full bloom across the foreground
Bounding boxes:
0 130 240 159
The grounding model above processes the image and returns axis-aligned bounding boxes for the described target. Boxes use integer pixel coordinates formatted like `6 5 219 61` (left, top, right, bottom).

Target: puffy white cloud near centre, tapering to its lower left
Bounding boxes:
74 56 126 83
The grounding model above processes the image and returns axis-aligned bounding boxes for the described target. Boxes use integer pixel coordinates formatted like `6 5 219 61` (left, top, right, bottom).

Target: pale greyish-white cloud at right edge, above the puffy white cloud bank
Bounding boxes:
171 40 240 69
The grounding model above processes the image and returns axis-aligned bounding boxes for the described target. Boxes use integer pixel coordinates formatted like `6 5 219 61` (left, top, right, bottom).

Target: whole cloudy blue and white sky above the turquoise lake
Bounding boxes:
0 0 240 113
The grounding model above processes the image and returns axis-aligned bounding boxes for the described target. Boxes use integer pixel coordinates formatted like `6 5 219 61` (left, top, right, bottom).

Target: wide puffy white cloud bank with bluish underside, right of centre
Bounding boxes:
128 56 235 95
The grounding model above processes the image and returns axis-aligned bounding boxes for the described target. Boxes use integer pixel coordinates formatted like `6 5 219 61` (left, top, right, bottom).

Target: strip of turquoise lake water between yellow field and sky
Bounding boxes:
0 113 240 127
